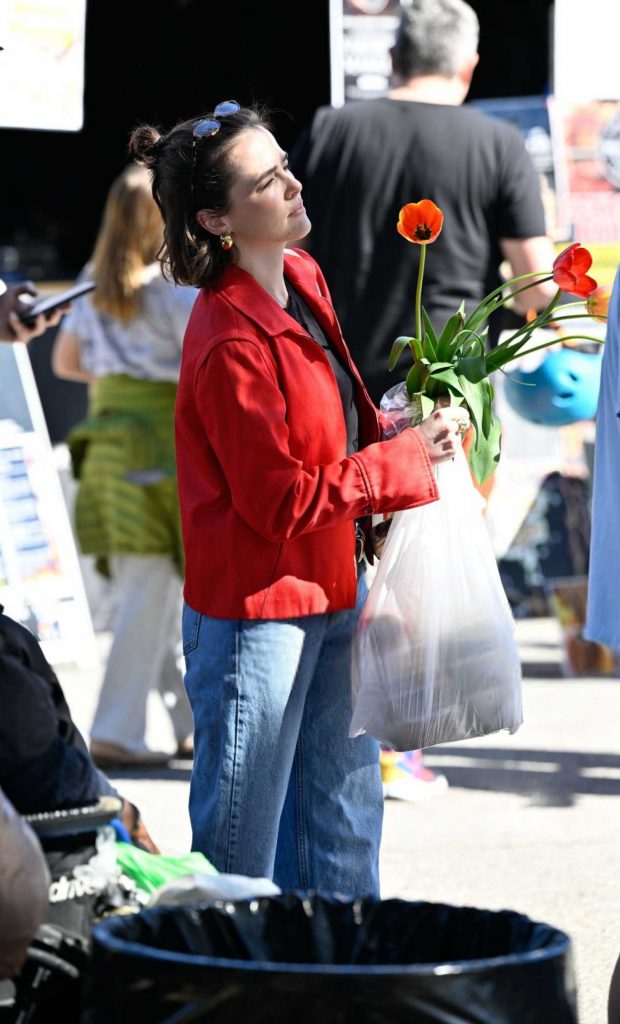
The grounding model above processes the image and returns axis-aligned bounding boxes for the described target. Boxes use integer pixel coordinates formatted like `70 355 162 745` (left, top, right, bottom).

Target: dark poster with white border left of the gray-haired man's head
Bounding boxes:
330 0 406 106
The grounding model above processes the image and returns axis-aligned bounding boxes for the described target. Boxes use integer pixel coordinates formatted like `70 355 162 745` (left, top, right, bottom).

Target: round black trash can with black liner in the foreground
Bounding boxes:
82 893 577 1024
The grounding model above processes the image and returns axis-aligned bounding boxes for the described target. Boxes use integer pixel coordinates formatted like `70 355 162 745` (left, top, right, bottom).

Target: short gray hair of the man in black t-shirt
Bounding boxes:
391 0 480 79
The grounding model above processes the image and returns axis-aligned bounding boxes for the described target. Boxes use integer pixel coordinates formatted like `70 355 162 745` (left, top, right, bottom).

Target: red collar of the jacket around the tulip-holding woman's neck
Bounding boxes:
215 250 339 340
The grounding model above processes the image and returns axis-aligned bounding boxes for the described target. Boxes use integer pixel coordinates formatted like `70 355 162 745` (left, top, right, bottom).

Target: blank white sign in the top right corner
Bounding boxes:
553 0 620 102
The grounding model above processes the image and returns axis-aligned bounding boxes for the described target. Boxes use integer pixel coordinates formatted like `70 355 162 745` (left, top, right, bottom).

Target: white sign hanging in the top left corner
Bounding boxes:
0 0 86 131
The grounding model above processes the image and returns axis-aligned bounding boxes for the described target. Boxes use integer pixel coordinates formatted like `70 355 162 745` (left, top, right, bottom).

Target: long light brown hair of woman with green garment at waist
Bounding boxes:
91 164 164 323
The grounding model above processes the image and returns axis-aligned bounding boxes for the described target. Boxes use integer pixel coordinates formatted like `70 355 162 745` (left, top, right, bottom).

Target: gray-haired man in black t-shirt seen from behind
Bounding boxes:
291 0 554 402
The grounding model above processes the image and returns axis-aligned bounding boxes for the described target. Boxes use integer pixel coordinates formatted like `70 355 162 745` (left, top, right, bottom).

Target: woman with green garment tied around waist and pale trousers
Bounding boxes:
52 164 197 769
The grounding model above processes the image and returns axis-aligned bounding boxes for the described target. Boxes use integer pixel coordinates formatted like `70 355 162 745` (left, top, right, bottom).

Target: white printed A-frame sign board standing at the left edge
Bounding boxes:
0 345 98 668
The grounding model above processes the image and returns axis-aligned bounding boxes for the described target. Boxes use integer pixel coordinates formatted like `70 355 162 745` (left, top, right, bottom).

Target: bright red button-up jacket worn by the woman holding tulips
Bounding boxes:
175 250 438 618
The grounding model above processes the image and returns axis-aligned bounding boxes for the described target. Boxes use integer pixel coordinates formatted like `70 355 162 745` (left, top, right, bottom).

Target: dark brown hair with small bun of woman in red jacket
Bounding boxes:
129 106 271 288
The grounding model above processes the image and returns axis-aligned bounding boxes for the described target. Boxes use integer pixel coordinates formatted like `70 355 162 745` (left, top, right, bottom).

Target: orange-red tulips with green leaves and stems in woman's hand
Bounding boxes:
388 199 606 483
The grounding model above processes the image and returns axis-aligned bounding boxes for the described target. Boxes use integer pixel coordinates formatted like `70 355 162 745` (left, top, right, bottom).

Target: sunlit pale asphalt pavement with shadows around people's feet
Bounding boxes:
56 618 620 1024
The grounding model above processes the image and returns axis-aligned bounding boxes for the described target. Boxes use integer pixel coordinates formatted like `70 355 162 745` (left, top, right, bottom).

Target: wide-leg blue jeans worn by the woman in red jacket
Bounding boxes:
182 574 383 897
